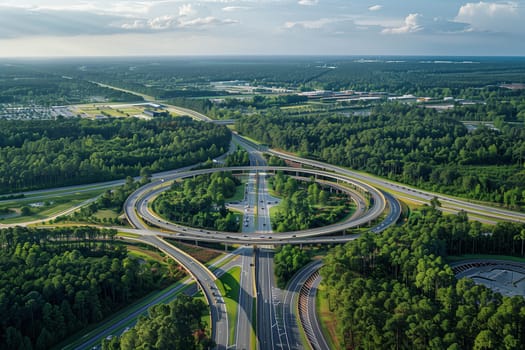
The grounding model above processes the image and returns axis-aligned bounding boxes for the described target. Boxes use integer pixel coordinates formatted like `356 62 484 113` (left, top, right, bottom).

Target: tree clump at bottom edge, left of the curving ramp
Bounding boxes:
102 295 214 350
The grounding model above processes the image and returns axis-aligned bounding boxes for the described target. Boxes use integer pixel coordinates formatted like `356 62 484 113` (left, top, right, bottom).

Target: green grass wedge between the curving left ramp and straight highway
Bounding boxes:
216 266 241 345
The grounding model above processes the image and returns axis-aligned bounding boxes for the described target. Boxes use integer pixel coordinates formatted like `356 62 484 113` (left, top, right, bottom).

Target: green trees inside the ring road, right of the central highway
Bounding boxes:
270 172 348 232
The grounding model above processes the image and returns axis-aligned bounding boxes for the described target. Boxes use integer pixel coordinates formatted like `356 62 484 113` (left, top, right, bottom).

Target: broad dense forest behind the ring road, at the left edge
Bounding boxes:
0 117 231 193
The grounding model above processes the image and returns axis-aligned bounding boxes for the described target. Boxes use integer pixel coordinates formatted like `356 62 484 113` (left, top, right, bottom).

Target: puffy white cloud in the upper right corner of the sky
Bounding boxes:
455 1 523 32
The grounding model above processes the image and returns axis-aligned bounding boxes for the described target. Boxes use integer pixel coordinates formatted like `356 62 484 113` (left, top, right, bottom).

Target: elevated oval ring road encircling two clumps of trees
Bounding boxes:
124 166 399 244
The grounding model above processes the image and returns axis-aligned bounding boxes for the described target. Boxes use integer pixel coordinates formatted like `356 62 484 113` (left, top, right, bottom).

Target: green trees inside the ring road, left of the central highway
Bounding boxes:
153 172 240 232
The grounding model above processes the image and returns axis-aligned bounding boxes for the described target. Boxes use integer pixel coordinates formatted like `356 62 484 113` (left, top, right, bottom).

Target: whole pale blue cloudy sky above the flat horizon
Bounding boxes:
0 0 525 57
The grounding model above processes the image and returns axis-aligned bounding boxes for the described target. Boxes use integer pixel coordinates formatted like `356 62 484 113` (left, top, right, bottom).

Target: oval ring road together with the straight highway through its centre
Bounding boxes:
118 135 400 349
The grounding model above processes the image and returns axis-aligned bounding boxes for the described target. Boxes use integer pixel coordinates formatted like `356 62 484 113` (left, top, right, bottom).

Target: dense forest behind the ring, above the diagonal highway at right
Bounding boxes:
236 104 525 209
